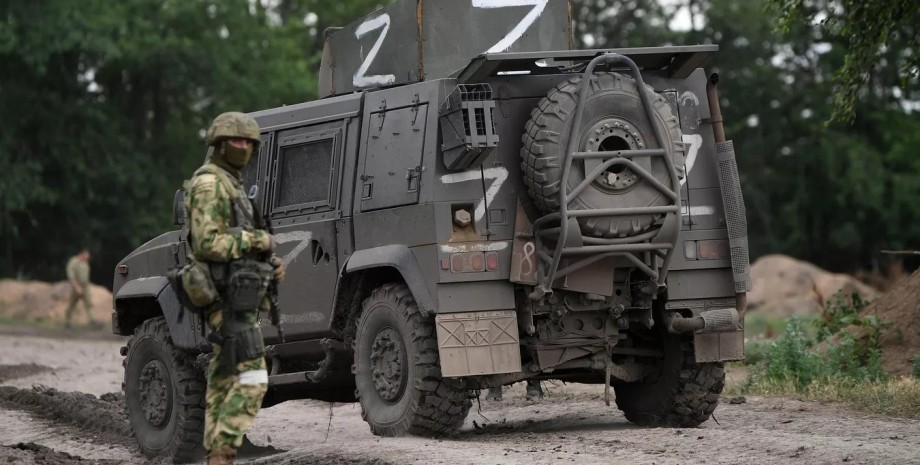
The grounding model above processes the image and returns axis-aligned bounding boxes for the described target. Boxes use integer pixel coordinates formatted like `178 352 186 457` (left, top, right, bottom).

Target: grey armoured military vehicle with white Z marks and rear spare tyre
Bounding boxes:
112 0 750 462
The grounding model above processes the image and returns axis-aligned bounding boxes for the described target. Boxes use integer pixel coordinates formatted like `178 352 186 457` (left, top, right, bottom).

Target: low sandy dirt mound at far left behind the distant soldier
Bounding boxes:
0 279 112 324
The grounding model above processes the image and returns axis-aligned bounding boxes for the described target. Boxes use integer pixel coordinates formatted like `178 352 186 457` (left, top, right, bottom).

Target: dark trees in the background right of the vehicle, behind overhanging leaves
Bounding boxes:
687 0 920 271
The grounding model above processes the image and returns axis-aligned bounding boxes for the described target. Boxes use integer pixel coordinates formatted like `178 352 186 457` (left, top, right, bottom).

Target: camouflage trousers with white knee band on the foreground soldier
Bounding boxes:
204 310 268 453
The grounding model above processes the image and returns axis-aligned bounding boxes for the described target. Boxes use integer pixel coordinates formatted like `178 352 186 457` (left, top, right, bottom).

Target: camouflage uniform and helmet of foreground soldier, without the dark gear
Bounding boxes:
186 113 273 463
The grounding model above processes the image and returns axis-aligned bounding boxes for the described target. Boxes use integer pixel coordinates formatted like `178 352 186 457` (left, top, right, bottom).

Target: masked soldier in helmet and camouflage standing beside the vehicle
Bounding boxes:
185 112 284 465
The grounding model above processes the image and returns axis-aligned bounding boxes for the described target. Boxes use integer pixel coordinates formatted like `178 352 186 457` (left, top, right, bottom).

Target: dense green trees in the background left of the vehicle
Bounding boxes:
0 0 376 284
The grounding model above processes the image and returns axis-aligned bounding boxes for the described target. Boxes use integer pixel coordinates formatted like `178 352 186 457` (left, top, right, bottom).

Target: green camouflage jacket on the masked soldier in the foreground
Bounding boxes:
185 163 270 262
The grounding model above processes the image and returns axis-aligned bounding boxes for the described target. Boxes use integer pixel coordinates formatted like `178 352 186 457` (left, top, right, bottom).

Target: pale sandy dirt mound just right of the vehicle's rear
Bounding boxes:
748 255 878 317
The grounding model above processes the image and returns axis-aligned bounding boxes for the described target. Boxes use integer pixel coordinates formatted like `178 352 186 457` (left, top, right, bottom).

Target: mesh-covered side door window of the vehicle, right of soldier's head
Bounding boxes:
275 139 334 207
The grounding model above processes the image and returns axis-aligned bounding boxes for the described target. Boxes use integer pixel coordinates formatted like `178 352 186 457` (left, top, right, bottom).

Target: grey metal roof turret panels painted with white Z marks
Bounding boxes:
319 0 572 97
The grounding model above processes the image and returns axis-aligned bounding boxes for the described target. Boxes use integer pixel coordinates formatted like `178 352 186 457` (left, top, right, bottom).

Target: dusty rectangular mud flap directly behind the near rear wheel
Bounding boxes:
435 310 521 377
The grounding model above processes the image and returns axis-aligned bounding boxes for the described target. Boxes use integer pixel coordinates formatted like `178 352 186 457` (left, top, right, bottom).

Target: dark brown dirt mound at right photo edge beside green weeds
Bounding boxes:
862 270 920 375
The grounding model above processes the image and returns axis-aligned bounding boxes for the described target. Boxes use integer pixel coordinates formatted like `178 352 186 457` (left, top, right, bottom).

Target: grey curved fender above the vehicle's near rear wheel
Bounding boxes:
342 244 437 314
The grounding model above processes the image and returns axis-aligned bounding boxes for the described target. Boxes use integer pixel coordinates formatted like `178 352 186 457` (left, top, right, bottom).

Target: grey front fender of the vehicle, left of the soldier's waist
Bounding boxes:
113 276 208 350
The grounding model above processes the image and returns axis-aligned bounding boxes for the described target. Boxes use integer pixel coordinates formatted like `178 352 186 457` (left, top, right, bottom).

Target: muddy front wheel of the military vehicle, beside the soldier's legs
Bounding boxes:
122 317 207 463
